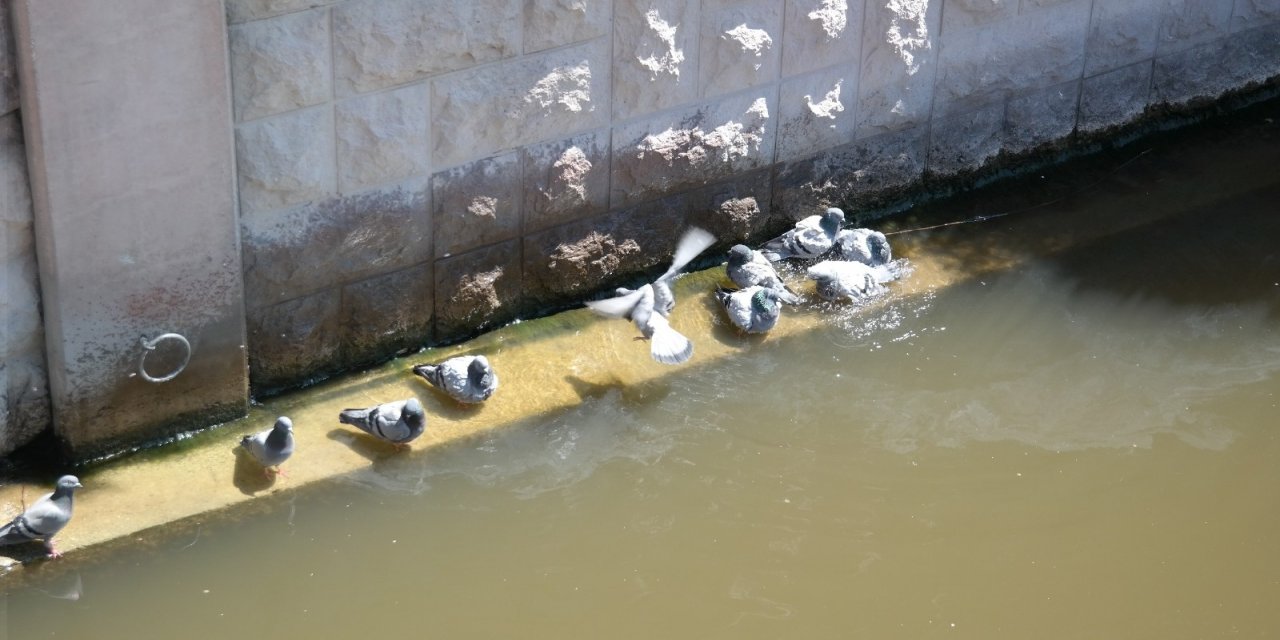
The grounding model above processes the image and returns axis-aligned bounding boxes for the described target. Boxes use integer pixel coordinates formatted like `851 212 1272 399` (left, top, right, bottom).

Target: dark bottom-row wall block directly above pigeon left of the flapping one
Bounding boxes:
435 241 524 342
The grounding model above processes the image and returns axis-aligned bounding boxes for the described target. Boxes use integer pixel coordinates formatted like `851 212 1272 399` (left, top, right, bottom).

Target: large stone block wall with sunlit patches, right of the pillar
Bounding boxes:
227 0 1280 392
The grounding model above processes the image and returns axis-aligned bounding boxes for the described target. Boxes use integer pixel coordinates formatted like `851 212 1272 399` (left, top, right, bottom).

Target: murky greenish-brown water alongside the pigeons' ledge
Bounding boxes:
0 102 1280 639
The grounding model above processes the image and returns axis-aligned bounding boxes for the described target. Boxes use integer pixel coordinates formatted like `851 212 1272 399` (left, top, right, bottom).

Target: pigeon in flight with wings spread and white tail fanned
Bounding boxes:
586 227 716 365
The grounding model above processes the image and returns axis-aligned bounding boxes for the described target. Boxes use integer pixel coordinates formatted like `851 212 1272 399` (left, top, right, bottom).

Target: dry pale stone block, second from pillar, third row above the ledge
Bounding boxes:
334 84 430 193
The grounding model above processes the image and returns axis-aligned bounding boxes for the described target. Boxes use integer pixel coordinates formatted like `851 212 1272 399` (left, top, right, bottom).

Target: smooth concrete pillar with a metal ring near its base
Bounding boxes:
13 0 248 460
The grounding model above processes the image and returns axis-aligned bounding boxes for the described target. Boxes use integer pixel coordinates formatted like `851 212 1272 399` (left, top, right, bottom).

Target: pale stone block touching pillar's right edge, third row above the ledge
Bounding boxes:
236 106 335 215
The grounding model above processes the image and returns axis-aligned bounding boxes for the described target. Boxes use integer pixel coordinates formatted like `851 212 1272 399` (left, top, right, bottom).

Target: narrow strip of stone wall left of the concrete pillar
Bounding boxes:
0 1 49 456
